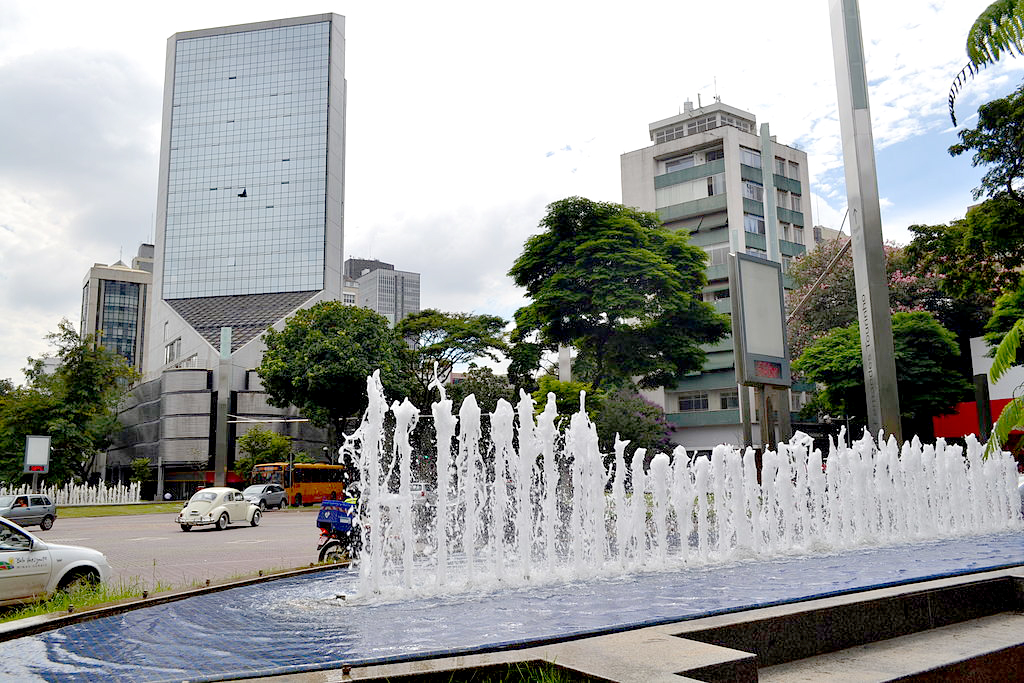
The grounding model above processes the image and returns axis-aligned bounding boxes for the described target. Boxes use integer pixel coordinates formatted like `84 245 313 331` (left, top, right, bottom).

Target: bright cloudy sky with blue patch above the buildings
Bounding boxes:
0 0 1024 384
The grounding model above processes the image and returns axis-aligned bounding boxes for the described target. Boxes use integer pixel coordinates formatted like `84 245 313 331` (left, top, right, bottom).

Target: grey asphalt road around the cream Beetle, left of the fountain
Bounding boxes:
37 506 319 590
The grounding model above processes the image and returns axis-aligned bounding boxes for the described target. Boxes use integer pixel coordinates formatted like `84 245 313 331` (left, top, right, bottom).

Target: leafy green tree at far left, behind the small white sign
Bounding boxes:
0 319 137 483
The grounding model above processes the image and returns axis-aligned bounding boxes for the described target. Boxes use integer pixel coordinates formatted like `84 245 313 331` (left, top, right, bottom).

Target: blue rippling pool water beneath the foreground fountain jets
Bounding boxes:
0 531 1024 681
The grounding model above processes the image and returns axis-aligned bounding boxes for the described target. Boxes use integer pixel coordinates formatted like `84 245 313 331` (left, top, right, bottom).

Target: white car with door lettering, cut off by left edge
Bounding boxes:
0 519 111 605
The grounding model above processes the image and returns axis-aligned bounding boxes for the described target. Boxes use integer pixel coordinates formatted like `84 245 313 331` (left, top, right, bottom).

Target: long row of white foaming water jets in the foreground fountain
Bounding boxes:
345 368 1022 595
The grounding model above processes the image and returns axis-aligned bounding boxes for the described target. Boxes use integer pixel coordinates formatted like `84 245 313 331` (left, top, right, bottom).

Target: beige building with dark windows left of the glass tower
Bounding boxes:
79 244 153 371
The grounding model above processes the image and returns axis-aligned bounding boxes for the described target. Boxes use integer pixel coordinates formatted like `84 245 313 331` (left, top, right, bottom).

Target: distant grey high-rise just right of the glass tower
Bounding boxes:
345 258 420 327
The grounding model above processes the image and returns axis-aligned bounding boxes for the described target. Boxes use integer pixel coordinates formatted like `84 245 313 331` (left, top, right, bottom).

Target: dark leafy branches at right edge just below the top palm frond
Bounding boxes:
949 86 1024 208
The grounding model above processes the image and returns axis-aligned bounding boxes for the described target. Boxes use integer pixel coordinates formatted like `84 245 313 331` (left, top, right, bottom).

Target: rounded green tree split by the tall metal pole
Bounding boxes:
794 311 971 438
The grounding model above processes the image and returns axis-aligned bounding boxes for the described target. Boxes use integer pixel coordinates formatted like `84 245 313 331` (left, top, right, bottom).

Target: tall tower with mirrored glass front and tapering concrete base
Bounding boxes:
111 14 346 493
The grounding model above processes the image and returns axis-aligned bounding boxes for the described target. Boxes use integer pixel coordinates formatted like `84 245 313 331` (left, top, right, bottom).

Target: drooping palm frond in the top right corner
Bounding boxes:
949 0 1024 126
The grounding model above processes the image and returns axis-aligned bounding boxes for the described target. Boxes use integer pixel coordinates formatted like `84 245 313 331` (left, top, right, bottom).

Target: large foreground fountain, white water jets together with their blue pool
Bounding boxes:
0 374 1024 681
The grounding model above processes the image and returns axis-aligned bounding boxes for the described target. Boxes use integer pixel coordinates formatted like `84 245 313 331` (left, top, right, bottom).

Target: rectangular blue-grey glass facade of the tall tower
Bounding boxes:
162 22 331 299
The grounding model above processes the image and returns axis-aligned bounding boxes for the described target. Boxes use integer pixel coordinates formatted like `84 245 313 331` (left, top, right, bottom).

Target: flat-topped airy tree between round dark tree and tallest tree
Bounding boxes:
395 308 507 409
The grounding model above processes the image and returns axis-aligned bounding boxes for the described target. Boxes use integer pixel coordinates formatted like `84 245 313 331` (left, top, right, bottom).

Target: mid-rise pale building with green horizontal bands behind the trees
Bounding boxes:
621 101 815 451
